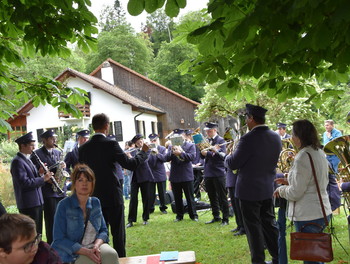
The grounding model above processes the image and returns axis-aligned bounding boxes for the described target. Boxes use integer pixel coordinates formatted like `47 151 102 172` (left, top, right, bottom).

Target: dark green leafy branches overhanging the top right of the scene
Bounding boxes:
128 0 350 104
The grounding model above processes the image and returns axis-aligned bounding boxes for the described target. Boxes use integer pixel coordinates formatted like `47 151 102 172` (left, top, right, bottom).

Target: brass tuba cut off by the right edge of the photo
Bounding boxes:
323 135 350 210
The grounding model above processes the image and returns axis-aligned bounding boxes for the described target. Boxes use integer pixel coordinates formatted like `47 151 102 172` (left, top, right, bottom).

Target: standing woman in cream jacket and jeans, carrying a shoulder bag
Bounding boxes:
274 120 332 263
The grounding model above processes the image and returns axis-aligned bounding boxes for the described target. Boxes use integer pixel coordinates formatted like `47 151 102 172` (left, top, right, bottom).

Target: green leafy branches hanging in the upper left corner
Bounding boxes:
0 0 97 132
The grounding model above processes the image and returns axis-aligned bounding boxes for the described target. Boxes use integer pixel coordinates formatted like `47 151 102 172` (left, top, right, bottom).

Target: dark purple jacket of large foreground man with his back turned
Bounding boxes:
225 126 282 201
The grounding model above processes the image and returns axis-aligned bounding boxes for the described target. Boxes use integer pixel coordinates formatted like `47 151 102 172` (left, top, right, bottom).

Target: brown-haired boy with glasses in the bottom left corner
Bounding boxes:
0 214 62 264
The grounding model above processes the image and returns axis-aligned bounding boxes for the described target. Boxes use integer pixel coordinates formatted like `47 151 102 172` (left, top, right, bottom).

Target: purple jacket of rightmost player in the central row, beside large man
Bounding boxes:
202 135 226 178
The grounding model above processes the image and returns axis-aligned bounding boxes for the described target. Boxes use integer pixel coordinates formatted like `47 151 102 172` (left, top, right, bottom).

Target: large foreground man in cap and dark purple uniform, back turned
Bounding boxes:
225 104 282 264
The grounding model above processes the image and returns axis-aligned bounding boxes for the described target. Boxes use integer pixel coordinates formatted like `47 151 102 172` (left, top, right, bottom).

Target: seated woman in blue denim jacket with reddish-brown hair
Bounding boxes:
52 164 119 264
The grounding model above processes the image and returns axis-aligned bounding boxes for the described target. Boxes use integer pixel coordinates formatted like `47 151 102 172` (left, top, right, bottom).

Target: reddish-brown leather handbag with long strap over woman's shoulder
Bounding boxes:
290 153 333 262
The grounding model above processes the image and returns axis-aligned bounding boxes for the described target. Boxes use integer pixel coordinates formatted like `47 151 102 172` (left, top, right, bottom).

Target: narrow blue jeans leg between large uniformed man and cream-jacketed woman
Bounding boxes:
277 207 288 264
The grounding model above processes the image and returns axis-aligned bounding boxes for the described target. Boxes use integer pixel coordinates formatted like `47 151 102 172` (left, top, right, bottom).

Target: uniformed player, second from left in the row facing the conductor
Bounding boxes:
148 133 168 214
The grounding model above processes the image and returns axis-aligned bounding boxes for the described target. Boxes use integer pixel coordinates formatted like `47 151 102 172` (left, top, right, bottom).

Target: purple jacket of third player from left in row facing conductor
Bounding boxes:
164 141 196 182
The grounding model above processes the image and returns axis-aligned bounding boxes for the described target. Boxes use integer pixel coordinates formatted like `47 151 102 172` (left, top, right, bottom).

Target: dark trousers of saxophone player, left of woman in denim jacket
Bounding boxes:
44 197 63 244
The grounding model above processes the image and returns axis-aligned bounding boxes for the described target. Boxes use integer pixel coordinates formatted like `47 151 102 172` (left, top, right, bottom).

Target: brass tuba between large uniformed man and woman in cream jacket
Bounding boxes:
277 138 298 173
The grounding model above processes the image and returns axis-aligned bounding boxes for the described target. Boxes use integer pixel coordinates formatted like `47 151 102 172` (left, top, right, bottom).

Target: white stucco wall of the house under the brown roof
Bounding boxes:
27 78 157 148
